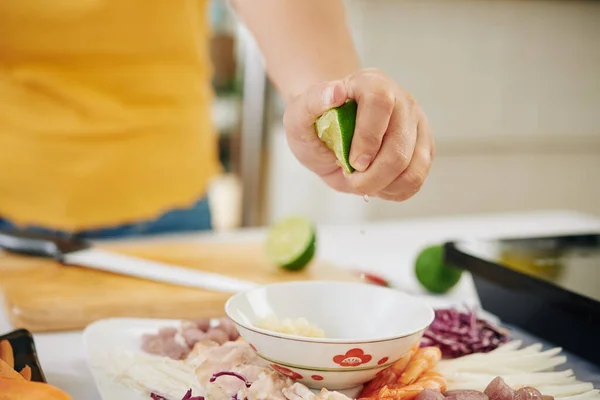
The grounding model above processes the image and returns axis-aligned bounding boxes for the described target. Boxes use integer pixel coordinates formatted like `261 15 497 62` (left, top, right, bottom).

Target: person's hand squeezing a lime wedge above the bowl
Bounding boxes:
284 69 435 201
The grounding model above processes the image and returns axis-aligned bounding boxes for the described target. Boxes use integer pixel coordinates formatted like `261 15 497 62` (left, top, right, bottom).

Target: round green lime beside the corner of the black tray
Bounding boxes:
415 245 463 294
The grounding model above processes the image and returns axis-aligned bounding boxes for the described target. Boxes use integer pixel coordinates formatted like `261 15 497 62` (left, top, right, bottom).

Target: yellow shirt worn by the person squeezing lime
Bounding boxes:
0 0 219 230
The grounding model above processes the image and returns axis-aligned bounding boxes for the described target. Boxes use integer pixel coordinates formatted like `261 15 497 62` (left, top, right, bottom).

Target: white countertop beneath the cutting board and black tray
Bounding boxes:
0 211 600 400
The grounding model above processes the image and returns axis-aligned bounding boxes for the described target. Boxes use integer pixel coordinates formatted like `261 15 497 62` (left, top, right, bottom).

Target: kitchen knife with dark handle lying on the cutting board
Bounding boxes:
0 230 258 293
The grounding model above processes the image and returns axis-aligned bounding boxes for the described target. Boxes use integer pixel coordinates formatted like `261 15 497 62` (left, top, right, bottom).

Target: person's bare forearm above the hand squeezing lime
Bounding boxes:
232 0 360 101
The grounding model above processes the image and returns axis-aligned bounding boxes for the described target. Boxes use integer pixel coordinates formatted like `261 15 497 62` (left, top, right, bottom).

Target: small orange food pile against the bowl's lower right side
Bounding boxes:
358 347 446 400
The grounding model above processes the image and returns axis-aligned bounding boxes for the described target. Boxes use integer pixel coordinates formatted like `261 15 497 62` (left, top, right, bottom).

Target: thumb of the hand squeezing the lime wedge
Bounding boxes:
287 80 348 128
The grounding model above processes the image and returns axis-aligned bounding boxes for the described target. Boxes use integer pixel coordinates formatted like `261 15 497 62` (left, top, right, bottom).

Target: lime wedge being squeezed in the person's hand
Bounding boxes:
315 100 358 173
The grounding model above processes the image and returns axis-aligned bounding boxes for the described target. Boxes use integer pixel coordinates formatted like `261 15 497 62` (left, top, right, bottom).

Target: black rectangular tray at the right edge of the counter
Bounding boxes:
444 233 600 365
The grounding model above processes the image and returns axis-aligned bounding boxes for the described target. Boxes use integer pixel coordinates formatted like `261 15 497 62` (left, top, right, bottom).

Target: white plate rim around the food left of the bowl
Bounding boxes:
83 318 358 400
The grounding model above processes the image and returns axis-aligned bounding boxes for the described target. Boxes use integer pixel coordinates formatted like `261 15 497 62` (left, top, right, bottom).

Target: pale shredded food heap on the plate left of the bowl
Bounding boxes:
107 340 350 400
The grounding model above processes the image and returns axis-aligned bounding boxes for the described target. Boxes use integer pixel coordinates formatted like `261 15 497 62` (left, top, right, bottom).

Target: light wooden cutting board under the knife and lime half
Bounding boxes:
0 242 360 333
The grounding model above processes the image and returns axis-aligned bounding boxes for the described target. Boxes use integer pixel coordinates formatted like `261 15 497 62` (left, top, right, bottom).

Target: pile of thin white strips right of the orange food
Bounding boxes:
435 341 600 400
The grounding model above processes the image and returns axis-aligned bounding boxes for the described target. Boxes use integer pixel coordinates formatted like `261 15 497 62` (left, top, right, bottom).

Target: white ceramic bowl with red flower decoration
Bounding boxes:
225 281 434 390
